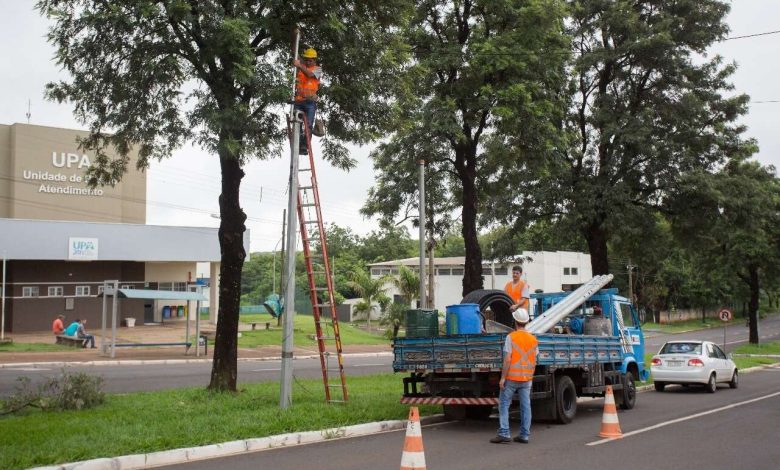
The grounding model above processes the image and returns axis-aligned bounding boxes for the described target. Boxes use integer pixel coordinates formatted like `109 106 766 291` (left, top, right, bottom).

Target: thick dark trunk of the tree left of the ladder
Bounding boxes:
208 149 246 392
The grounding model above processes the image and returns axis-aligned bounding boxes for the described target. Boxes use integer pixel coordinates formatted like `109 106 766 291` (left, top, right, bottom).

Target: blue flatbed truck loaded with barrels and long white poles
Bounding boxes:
393 275 649 424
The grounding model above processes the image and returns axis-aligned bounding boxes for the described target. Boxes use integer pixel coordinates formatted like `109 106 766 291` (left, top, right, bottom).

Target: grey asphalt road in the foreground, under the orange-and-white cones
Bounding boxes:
164 367 780 470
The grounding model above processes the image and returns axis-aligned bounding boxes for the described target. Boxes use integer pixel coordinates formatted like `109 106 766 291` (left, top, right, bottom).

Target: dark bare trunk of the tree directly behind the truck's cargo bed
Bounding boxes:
456 151 483 297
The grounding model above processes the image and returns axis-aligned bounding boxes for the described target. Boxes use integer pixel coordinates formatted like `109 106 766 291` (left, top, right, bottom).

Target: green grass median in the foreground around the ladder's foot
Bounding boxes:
0 374 432 469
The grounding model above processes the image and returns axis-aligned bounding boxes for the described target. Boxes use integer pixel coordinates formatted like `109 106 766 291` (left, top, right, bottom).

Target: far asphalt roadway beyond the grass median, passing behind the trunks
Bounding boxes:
0 315 780 397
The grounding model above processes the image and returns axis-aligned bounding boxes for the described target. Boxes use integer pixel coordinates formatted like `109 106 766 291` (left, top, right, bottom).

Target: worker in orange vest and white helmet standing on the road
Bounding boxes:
490 308 539 444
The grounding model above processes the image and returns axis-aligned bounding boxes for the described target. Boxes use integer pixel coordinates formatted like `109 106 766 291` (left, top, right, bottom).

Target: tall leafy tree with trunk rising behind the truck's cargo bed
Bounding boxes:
364 0 568 294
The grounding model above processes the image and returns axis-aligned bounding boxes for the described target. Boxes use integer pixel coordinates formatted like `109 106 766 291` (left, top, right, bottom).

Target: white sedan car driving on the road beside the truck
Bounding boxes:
650 341 739 393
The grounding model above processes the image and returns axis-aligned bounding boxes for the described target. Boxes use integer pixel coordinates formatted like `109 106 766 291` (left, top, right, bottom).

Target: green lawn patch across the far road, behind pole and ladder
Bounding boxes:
238 313 390 348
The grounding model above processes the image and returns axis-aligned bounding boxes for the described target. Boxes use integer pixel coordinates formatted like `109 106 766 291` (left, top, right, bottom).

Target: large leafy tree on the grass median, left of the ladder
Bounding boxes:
38 0 407 391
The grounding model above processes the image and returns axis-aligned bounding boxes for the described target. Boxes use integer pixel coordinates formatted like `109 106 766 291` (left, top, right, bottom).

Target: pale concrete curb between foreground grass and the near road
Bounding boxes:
31 415 444 470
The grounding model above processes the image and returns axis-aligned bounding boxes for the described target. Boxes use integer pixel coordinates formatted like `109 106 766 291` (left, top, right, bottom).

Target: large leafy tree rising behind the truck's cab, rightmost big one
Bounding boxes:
493 0 753 274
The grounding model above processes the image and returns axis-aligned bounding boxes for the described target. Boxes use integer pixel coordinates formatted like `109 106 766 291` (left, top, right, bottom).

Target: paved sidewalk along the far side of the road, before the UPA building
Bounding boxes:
0 323 392 368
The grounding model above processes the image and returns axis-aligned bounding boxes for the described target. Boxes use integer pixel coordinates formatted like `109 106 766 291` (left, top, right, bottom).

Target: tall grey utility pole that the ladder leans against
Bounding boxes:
279 28 302 409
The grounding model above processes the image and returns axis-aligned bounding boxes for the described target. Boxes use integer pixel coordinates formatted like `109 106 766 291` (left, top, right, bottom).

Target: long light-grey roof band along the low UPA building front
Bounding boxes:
0 218 244 262
